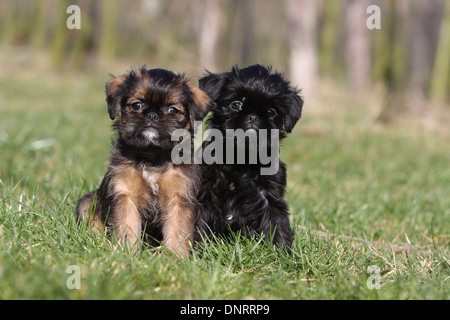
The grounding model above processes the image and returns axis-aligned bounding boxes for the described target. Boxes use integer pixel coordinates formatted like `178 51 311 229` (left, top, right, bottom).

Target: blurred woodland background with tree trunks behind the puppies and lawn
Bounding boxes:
0 0 450 126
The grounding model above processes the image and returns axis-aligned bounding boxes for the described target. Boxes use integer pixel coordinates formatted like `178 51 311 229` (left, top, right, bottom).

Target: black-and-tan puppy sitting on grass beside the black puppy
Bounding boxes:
76 67 210 255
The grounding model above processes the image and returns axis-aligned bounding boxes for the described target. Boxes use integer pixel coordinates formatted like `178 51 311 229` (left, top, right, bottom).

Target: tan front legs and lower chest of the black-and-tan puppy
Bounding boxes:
107 164 194 256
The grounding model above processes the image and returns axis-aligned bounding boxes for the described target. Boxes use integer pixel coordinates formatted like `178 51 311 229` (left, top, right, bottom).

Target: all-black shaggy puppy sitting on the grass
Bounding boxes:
194 65 303 252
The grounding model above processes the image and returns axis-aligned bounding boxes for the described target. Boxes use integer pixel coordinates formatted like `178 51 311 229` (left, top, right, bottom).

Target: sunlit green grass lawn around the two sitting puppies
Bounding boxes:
0 76 450 299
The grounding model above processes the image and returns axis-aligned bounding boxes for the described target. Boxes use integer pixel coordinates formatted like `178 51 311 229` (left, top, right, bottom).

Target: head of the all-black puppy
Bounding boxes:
199 65 303 137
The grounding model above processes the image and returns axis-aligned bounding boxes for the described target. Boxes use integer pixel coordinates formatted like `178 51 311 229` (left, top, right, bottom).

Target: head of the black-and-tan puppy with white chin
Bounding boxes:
106 68 210 149
